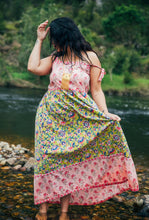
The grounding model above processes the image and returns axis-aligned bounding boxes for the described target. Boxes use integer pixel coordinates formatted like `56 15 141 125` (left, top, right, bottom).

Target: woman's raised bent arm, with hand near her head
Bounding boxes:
27 20 52 76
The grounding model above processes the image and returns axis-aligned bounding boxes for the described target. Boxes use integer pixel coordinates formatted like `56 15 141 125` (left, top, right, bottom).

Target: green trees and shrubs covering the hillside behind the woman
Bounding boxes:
0 0 149 87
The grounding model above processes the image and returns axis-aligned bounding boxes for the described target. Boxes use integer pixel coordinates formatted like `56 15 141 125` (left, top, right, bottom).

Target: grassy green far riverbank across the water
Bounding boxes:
0 72 149 96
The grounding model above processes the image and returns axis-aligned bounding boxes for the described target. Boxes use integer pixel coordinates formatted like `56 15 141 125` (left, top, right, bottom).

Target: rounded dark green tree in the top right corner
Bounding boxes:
103 5 145 47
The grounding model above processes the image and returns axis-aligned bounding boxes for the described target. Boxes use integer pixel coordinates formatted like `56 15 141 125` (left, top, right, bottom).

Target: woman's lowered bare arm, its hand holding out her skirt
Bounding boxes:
88 52 121 121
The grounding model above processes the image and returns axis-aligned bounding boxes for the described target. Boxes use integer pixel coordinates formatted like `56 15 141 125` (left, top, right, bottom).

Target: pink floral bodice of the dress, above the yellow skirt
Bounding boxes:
48 58 105 93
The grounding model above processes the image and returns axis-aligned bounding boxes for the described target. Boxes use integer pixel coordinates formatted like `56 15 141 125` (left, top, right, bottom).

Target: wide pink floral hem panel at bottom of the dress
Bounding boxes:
34 154 139 205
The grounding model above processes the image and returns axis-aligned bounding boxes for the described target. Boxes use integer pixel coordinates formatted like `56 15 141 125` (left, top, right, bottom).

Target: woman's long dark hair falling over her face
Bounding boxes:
49 17 93 62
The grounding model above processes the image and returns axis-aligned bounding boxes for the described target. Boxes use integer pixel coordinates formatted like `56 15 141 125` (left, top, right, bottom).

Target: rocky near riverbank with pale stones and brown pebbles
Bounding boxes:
0 141 149 220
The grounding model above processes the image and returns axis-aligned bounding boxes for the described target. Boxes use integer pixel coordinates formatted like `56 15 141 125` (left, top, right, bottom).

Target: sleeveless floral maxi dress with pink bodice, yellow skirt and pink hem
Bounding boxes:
34 58 139 205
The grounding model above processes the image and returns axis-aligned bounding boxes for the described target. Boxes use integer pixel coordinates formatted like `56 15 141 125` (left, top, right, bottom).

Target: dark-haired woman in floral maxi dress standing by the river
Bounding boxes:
28 18 138 220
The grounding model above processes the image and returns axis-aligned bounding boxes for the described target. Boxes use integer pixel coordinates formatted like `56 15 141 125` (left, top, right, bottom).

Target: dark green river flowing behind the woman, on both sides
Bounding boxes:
0 88 149 165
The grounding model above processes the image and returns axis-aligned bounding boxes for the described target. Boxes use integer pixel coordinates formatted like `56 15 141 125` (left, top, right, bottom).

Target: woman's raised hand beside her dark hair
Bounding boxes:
37 20 50 41
